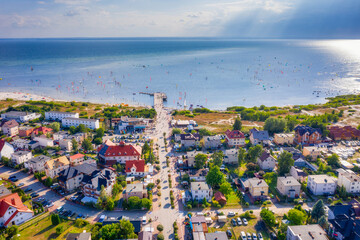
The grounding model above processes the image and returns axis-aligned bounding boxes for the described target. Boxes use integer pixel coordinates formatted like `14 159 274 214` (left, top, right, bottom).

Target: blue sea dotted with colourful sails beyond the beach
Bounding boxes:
0 38 360 110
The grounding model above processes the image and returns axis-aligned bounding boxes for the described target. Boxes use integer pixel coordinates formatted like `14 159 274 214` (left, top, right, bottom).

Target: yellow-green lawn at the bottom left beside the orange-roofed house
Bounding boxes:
20 216 91 240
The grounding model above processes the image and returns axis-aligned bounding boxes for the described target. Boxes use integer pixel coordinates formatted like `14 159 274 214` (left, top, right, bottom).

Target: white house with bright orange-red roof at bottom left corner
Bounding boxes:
0 193 34 227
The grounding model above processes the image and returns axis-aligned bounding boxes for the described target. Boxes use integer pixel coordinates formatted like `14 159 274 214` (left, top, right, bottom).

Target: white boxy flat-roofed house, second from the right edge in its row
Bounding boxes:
307 174 337 195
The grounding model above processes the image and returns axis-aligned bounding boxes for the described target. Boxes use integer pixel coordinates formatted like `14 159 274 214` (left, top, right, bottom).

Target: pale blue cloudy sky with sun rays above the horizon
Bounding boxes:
0 0 360 39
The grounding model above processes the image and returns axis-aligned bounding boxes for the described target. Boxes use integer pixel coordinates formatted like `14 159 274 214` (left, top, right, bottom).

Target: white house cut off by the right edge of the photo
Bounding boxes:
337 168 360 193
